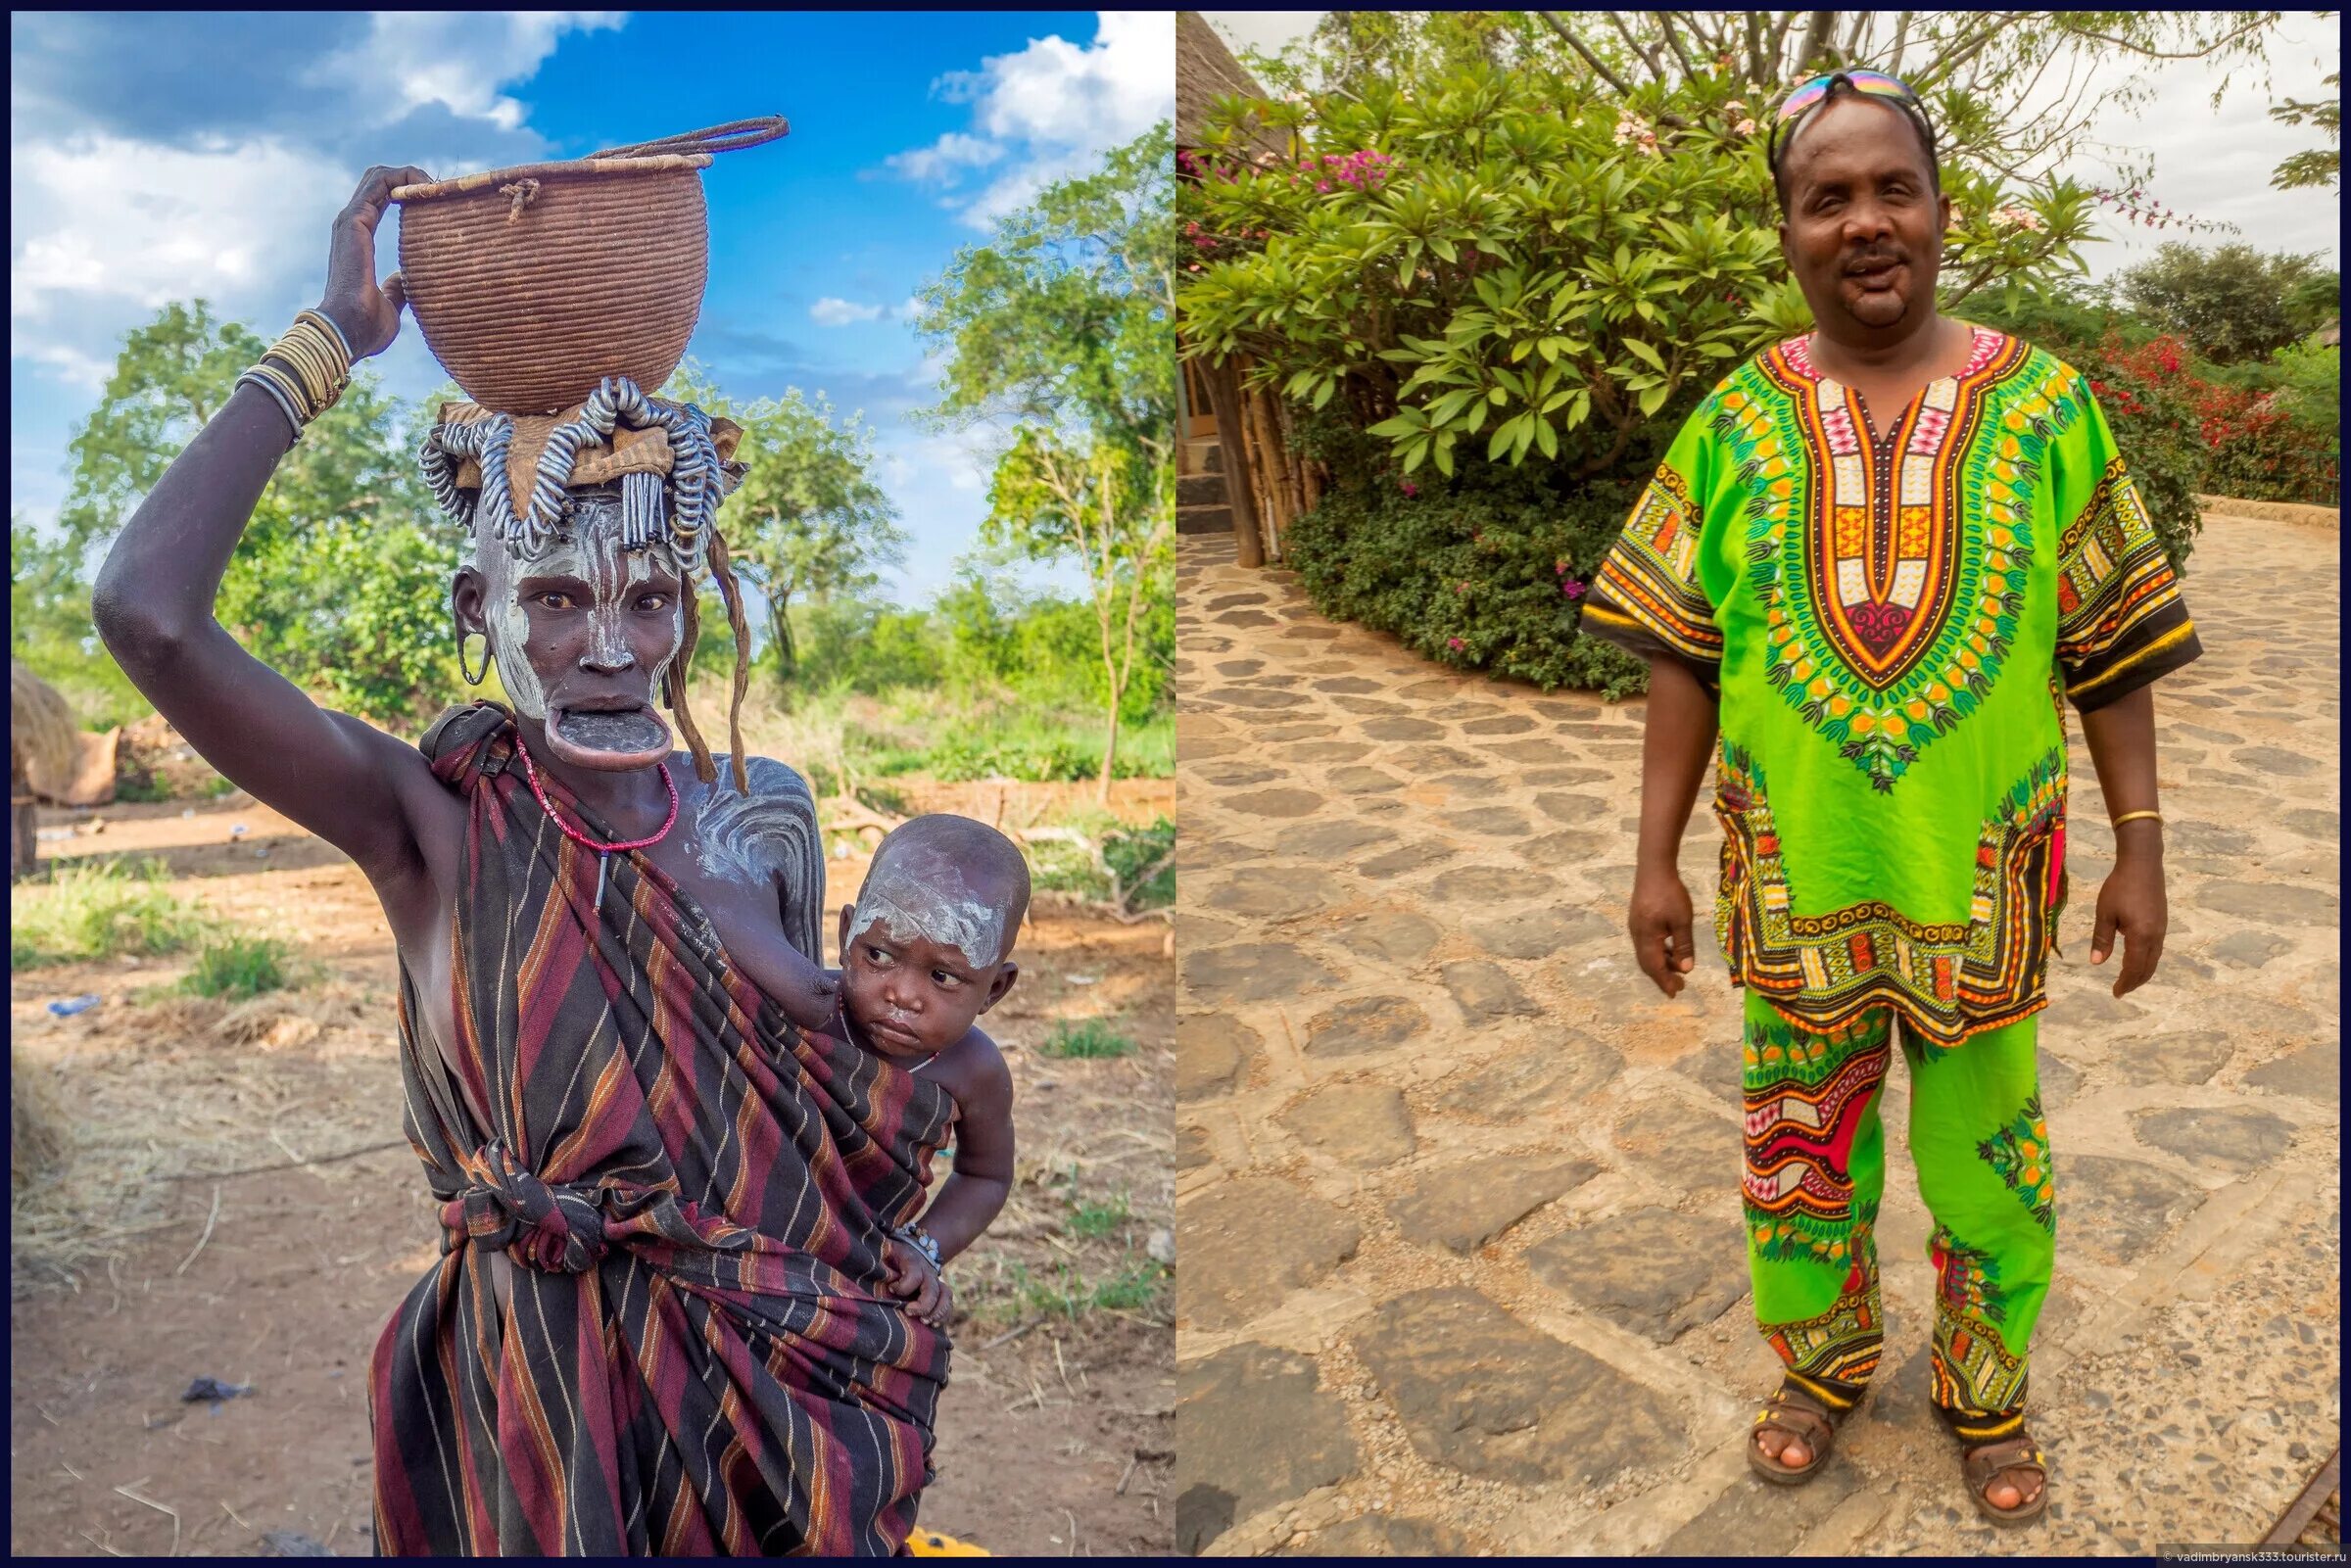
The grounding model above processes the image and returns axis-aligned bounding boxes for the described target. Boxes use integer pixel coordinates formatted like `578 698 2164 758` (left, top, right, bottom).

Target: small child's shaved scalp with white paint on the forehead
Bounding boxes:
848 811 1030 969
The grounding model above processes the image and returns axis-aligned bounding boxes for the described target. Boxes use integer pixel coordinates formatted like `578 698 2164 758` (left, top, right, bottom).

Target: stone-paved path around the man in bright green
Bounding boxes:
1177 517 2341 1556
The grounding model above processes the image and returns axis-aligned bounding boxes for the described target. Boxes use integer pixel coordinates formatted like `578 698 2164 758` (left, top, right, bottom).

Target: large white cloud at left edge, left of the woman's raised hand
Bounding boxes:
10 136 355 324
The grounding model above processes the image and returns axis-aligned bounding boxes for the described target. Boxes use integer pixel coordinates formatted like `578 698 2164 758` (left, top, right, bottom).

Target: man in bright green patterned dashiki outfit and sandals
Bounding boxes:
1585 71 2200 1523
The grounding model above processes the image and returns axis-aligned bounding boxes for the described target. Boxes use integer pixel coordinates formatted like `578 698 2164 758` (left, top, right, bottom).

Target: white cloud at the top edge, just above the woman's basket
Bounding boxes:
308 12 628 131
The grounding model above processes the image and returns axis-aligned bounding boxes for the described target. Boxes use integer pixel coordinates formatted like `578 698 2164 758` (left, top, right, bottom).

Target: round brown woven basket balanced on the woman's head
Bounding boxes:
393 116 788 413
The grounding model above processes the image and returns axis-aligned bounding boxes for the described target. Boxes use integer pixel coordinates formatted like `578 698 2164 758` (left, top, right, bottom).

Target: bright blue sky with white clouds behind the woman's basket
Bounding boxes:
10 12 1174 604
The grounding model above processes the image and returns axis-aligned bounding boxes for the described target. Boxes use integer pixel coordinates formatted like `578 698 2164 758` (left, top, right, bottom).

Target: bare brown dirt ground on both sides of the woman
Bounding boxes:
10 781 1174 1556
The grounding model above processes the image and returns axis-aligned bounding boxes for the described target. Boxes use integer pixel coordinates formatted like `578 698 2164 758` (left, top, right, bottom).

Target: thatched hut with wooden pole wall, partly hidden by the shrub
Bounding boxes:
1176 12 1321 566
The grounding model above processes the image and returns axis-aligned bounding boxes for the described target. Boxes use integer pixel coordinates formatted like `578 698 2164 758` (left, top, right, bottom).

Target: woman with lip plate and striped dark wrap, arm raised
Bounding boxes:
92 169 950 1556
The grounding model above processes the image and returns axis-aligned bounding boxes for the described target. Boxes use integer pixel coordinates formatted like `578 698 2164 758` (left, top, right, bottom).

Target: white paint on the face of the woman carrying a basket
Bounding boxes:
472 500 692 724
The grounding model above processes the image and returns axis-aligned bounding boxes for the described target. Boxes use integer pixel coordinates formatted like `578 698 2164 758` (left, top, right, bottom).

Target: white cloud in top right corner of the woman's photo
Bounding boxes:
884 12 1176 228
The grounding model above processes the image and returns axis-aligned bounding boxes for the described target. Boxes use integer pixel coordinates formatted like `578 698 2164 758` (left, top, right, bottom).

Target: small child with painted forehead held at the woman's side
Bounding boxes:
837 814 1030 1326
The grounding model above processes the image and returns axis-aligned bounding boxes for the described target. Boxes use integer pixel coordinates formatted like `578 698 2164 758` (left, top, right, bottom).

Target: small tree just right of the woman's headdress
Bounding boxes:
663 364 907 700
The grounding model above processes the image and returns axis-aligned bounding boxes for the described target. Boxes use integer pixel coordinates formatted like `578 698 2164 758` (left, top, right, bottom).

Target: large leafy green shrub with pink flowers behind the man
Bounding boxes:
1180 66 2092 695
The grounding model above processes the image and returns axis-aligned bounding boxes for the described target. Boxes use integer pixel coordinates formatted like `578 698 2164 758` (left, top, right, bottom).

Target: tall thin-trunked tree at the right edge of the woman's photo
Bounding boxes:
917 119 1177 799
